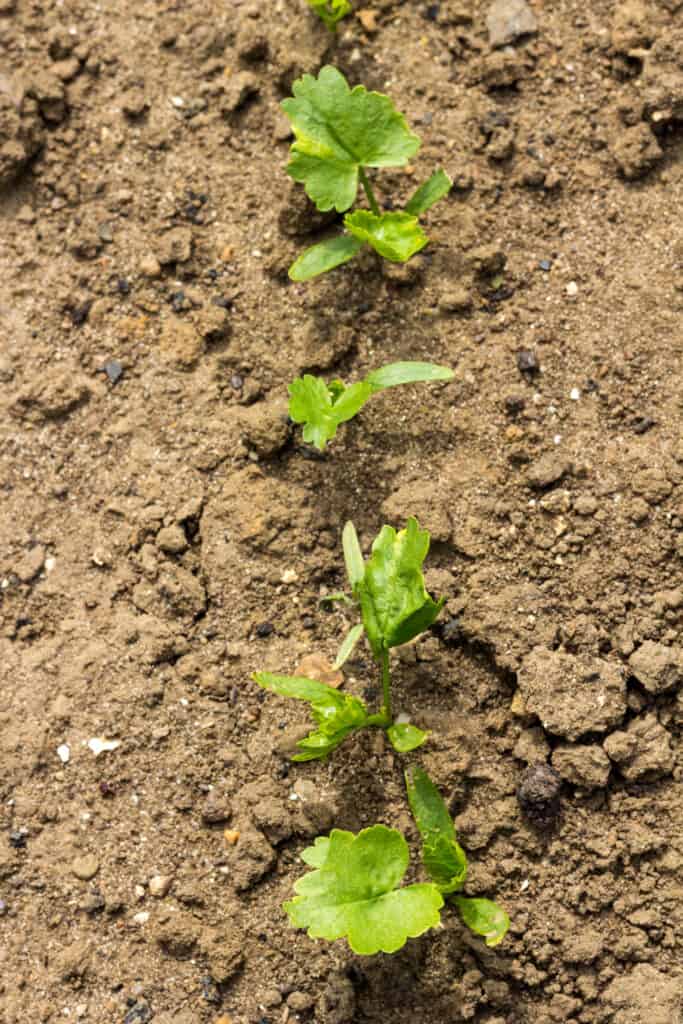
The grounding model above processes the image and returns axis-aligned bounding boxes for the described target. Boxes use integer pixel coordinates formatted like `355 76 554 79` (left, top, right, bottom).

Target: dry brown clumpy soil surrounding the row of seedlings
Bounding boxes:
0 0 683 1024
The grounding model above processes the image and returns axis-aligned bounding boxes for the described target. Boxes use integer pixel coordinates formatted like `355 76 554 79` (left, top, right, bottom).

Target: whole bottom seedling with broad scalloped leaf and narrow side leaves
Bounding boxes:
285 769 509 955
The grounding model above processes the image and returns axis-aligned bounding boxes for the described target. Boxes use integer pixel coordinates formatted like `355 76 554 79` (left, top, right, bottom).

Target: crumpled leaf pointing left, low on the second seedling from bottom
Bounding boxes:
252 672 368 761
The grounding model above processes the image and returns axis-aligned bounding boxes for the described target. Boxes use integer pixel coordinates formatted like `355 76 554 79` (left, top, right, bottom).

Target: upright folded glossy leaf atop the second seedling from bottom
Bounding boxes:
357 517 444 659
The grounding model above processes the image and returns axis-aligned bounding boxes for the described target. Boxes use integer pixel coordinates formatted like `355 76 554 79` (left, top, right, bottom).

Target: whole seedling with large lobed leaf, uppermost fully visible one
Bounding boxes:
282 66 453 281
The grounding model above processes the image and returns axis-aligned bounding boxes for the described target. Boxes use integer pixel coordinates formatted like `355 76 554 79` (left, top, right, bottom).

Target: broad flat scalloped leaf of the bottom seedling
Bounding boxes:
285 825 443 956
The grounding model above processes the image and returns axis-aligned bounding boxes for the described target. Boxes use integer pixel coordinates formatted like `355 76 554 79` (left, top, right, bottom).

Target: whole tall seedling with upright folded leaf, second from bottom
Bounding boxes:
253 518 443 761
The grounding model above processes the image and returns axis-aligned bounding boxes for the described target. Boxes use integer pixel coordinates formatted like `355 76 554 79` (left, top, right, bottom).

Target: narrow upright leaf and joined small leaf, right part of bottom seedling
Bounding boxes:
405 768 510 946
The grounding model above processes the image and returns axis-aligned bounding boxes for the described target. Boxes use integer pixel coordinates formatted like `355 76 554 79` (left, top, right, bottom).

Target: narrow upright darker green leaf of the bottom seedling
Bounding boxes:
405 768 467 893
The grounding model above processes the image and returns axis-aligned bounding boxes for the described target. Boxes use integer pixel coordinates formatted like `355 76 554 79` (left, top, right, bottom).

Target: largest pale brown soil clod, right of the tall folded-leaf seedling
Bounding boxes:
517 647 627 740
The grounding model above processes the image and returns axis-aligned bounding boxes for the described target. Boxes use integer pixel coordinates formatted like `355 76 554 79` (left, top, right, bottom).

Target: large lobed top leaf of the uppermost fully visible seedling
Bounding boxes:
282 65 420 213
